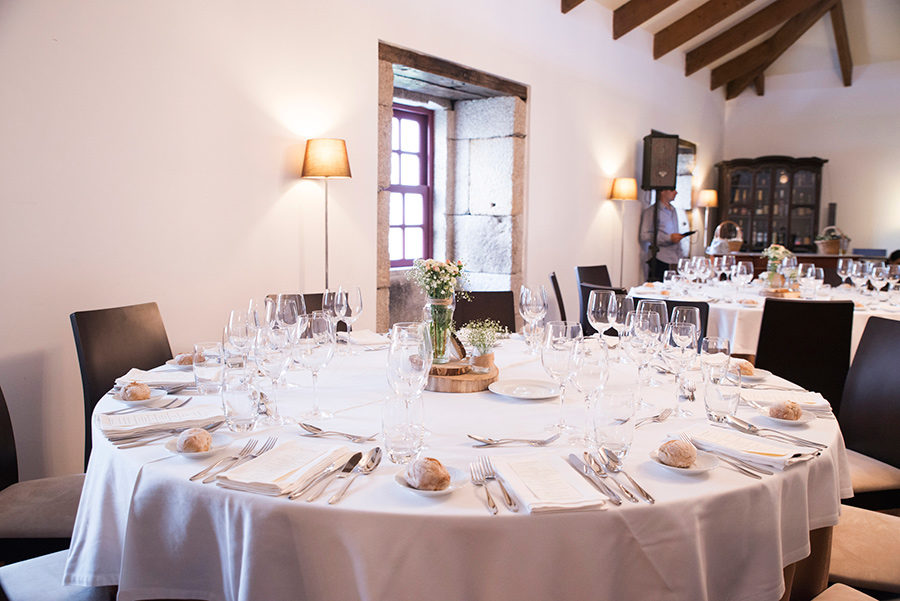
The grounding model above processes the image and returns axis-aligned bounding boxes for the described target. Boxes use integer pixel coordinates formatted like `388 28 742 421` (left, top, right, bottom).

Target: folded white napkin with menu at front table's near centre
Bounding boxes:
492 455 606 513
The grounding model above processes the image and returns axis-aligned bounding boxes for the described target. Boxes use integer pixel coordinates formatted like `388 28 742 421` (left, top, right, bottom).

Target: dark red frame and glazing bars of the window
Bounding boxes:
387 102 434 269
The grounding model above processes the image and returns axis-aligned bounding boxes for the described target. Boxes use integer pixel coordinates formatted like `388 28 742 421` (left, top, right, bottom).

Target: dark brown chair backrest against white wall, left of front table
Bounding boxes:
69 303 172 467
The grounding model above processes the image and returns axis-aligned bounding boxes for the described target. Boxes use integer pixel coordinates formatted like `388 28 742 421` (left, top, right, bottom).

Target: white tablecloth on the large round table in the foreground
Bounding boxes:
64 337 852 601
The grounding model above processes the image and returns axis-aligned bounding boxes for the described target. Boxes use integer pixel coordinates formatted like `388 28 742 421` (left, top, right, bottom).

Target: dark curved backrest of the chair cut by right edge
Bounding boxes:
840 317 900 468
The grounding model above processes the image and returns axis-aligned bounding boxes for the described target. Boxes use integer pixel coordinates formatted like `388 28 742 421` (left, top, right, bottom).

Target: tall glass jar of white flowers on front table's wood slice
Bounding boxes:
408 259 468 363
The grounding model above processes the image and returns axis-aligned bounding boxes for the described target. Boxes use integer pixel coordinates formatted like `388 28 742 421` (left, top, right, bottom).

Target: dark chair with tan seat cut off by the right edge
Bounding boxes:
840 317 900 509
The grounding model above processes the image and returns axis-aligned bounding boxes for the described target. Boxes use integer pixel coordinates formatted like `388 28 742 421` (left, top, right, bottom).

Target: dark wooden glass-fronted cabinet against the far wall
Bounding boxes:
716 156 828 252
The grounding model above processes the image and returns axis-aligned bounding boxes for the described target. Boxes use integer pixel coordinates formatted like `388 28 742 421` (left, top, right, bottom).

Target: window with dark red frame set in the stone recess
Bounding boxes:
388 104 434 267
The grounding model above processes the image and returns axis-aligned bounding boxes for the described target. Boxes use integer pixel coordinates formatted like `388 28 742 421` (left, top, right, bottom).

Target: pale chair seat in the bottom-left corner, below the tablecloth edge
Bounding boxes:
0 550 118 601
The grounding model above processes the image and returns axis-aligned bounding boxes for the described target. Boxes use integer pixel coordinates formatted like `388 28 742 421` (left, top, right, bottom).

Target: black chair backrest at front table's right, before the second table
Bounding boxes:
756 298 853 415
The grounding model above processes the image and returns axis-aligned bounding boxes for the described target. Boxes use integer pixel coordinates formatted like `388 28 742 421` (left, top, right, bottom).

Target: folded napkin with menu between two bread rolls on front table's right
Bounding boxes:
684 424 817 470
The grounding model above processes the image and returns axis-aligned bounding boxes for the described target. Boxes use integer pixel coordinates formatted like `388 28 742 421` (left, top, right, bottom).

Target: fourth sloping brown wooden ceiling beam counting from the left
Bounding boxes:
684 0 814 75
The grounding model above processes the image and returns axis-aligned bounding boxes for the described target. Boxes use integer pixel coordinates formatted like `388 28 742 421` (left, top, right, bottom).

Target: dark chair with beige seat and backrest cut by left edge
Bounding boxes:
0 390 84 563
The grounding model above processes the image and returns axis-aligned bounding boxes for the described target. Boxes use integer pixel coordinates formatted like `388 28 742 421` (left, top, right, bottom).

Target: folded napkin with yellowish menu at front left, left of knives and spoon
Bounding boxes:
216 441 352 497
